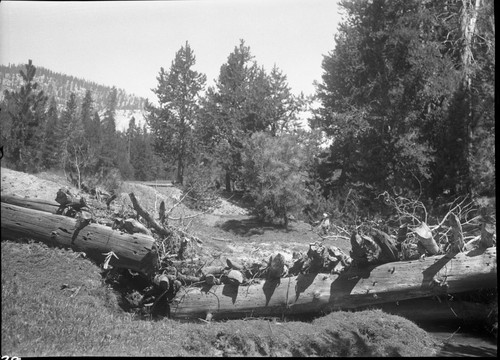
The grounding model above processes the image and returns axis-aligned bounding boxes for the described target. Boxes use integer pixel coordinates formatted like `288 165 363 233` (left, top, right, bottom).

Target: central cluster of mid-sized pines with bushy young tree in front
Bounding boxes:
146 40 309 225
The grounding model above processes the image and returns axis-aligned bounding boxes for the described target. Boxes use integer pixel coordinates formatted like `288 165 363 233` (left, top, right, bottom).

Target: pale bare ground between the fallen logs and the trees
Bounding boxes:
1 168 350 265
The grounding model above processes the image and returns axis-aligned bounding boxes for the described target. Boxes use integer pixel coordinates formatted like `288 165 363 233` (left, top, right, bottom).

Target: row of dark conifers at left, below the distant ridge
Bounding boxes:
0 60 165 187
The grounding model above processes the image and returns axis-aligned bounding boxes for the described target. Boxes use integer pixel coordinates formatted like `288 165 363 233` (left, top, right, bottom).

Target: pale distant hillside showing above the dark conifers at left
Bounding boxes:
0 64 146 131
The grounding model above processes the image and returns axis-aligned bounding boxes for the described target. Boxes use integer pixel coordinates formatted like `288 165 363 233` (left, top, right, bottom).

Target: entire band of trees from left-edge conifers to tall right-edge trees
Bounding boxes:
1 0 495 226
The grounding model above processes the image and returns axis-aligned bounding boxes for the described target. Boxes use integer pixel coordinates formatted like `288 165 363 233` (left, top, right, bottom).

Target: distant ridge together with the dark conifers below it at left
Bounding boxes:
0 60 164 183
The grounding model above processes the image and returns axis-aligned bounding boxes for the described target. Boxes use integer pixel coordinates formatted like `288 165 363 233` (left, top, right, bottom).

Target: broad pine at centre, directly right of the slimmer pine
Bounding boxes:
197 40 304 191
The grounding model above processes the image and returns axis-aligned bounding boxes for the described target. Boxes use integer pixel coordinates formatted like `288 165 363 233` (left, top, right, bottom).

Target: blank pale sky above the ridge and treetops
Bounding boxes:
0 0 340 101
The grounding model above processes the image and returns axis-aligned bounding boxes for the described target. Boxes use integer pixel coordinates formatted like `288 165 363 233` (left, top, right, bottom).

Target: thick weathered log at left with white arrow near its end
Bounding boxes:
1 202 158 276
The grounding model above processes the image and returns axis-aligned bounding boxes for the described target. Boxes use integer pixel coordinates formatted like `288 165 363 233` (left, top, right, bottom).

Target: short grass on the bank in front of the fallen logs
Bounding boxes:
1 241 437 357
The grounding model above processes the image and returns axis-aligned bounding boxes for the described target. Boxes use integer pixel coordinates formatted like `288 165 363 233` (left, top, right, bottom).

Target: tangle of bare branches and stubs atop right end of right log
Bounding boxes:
310 192 496 266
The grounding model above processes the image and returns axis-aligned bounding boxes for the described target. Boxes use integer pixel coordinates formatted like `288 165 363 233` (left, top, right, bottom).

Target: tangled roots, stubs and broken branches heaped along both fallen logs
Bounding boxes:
56 189 496 315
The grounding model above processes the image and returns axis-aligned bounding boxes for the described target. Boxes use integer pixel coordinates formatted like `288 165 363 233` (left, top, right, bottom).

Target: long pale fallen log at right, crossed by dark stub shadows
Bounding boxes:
170 247 497 319
